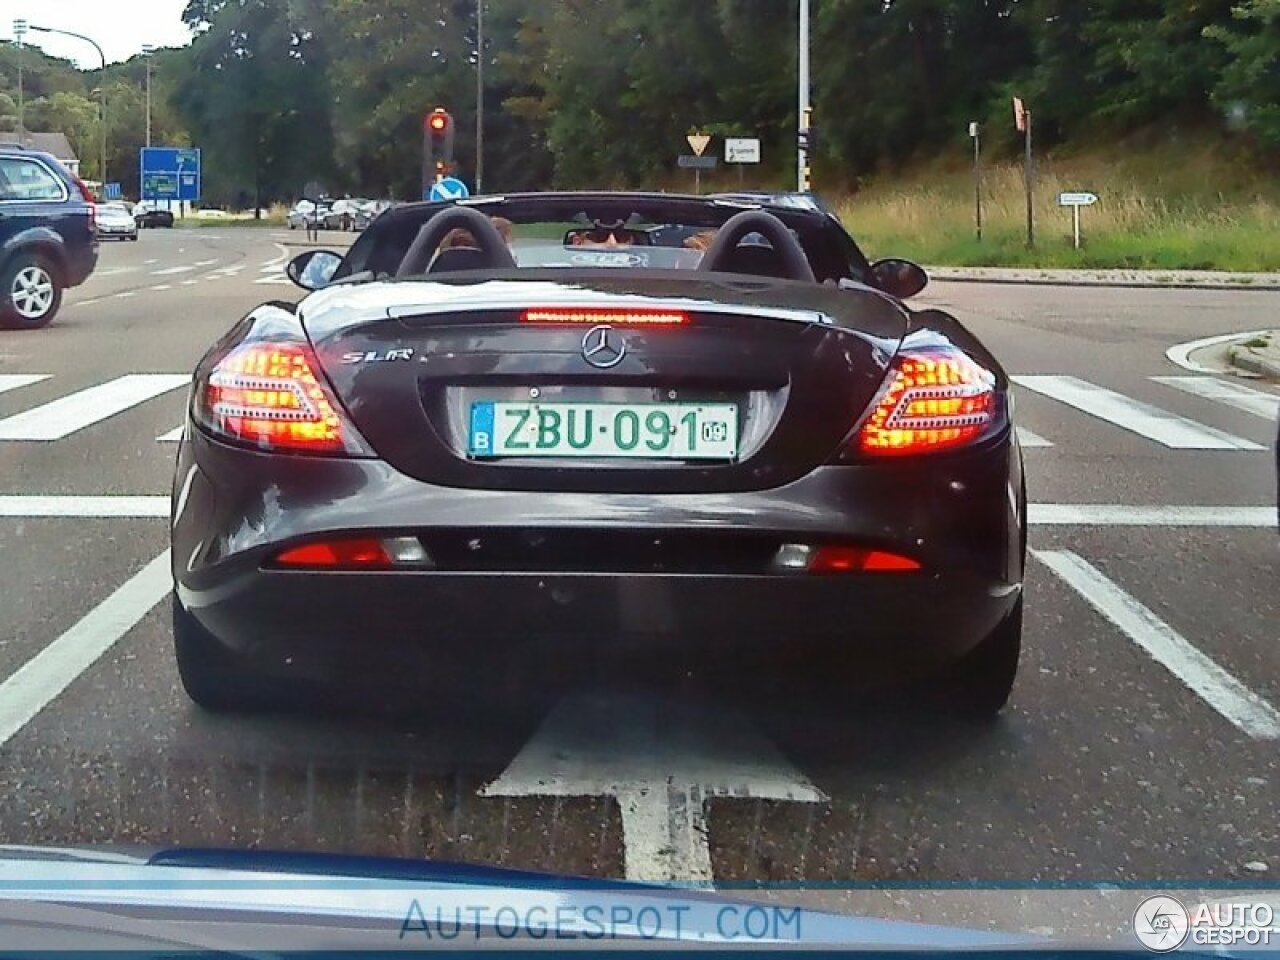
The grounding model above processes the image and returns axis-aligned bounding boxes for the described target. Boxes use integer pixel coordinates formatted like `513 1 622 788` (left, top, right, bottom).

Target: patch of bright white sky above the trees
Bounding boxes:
0 0 191 68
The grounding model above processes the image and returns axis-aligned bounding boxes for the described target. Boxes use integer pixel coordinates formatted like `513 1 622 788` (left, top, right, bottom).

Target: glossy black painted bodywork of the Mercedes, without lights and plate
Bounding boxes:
172 192 1027 698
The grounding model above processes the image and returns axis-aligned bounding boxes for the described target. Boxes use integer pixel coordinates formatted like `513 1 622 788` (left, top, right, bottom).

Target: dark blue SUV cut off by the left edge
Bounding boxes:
0 146 97 329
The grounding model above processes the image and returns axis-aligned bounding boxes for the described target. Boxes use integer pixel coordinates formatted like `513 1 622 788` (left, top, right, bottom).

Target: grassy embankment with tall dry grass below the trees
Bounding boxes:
837 140 1280 271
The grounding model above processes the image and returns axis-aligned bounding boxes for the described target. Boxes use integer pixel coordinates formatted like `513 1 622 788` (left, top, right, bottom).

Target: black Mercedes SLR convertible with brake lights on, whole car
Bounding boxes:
172 193 1025 714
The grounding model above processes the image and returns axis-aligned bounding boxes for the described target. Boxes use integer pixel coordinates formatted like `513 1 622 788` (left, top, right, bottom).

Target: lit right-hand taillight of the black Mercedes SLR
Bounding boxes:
858 348 997 456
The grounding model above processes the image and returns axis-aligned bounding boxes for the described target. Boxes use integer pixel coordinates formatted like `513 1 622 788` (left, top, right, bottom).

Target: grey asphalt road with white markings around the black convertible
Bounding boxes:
0 228 1280 901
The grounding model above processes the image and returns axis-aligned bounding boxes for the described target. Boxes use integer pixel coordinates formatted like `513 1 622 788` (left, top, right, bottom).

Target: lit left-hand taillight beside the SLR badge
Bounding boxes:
196 342 361 453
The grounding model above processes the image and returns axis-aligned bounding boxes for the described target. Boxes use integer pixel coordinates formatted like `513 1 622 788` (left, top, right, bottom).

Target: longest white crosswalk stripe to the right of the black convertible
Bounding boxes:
1012 376 1266 451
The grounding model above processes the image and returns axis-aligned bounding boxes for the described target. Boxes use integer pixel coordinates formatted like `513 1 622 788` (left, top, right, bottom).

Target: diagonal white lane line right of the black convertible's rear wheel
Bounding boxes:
1033 550 1280 740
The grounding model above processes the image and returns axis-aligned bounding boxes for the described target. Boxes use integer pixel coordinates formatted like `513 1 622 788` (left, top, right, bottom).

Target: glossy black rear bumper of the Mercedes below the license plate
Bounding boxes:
173 428 1024 686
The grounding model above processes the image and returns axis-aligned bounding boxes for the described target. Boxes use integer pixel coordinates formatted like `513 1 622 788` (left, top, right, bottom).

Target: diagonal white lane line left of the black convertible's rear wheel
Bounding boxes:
0 550 172 745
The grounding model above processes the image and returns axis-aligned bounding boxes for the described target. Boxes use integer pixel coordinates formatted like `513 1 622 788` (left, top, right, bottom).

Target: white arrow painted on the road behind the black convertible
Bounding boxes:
480 694 827 883
